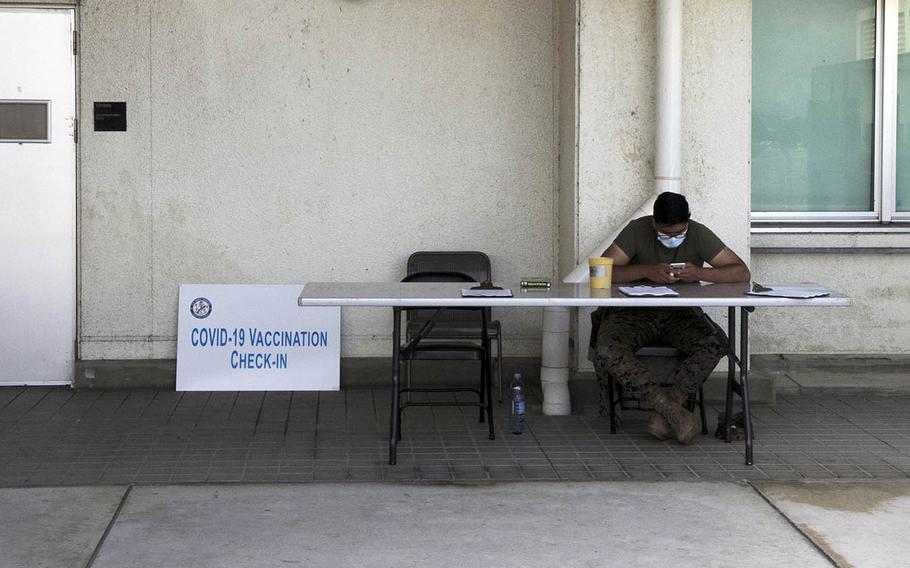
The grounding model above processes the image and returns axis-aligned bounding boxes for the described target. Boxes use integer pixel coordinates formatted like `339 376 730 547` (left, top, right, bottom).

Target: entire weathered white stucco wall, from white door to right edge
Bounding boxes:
51 0 910 368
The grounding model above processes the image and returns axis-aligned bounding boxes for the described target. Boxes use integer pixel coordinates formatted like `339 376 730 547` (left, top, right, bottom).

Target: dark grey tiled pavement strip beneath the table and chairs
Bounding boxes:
0 387 910 487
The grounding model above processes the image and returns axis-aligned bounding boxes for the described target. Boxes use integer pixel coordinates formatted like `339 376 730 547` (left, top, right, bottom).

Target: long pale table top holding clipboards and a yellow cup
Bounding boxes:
297 282 852 308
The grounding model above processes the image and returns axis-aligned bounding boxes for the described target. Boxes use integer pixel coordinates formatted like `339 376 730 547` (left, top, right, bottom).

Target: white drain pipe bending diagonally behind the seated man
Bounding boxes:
540 0 682 415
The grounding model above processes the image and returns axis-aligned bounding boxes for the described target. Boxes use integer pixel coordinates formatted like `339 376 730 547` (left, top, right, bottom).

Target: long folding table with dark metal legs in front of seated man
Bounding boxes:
298 282 852 465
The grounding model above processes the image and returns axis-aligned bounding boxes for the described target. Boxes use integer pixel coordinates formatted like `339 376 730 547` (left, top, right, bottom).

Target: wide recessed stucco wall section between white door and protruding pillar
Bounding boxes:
79 0 557 359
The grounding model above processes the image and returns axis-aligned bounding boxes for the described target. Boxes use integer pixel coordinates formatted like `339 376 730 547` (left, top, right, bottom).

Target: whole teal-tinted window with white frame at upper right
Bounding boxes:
752 0 910 223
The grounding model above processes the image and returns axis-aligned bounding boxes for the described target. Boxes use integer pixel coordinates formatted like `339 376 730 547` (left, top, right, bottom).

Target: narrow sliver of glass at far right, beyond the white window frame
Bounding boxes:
895 0 910 211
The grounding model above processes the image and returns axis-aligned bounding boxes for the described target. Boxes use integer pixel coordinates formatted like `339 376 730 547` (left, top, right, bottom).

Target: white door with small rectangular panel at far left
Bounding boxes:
0 7 76 386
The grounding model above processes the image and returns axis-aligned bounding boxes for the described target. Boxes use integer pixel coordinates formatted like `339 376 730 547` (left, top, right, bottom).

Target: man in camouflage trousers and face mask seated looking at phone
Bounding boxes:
591 192 751 444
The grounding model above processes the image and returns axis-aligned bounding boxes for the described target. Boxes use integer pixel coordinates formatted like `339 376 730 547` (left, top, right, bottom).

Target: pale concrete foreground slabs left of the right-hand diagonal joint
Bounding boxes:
0 482 848 568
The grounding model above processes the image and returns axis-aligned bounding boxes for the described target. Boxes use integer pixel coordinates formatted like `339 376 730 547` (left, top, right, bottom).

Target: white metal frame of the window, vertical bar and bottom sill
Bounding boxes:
751 0 910 226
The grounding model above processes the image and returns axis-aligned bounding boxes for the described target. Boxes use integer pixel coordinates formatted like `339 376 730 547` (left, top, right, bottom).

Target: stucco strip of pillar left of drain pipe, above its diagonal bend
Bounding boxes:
576 0 657 255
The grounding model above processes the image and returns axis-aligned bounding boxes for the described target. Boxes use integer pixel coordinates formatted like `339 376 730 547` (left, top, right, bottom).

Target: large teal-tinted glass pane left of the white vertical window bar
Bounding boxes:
752 0 875 212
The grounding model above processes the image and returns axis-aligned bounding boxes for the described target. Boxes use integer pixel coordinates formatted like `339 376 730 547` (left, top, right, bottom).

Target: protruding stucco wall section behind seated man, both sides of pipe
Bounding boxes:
576 0 752 369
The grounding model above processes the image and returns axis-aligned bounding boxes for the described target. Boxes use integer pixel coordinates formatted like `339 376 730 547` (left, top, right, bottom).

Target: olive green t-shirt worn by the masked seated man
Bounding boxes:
615 215 725 266
